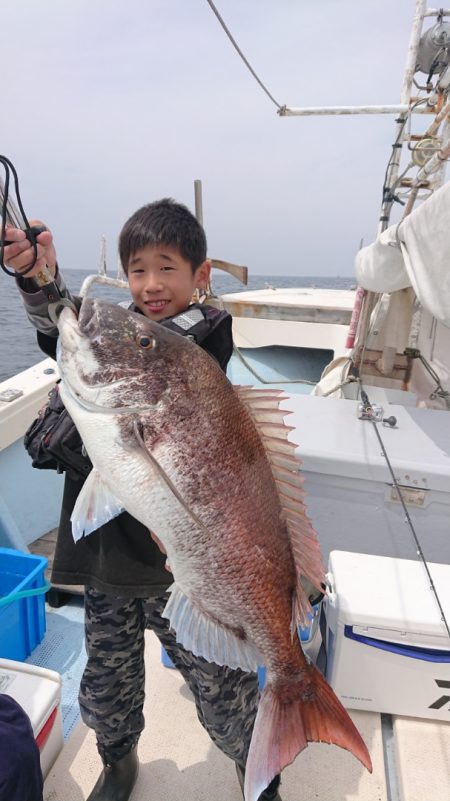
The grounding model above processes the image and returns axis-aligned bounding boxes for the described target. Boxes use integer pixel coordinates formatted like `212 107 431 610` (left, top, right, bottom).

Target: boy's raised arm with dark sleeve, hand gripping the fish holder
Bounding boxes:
4 220 73 337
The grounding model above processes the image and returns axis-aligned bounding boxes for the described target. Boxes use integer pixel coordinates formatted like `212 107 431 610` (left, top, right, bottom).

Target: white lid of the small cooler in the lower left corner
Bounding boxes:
0 659 61 737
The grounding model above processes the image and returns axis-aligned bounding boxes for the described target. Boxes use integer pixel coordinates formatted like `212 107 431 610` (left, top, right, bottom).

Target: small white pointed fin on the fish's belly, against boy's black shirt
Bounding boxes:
70 467 124 542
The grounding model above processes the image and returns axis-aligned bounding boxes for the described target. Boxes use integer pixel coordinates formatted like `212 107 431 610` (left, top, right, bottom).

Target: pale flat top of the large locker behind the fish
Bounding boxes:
281 387 450 494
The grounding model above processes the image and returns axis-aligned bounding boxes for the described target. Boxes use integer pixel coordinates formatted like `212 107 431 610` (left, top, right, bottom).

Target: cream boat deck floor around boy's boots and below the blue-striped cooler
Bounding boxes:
39 632 450 801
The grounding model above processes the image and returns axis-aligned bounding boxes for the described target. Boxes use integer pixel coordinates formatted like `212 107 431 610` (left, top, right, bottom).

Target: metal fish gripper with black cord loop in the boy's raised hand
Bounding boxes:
0 156 61 303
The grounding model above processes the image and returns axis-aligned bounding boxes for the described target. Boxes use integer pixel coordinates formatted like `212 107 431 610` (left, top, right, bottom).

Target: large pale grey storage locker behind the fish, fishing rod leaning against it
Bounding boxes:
282 394 450 564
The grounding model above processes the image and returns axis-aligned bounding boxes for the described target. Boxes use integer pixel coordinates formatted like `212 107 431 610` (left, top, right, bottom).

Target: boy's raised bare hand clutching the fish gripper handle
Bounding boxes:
3 220 56 278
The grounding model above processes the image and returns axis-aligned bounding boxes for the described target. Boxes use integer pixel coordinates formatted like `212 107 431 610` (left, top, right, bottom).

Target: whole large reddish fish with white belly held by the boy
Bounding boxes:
58 299 371 801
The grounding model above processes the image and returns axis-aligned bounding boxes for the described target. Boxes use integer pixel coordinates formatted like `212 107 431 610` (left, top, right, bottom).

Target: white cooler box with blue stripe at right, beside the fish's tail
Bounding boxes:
324 551 450 721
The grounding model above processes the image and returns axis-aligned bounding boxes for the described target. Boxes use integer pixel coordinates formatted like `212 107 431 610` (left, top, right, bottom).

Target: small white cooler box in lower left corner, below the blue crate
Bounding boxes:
0 659 64 779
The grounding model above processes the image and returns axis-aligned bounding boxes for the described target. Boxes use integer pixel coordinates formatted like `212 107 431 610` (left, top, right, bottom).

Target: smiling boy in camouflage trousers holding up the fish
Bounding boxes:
5 199 281 801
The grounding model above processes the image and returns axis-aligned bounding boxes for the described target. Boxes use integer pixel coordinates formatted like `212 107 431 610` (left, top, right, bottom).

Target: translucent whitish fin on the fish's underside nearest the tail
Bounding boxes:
162 584 262 671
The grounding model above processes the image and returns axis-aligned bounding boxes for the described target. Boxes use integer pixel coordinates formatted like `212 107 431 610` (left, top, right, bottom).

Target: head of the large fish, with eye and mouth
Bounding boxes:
57 297 197 408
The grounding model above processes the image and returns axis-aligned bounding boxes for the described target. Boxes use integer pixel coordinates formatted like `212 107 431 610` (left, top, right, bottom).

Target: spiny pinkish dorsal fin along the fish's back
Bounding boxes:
234 386 325 630
